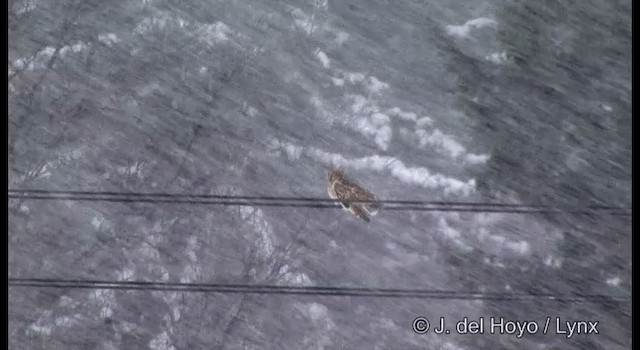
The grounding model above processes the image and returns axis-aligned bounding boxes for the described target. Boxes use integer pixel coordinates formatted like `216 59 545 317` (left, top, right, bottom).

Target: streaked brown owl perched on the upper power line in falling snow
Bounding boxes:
327 170 380 222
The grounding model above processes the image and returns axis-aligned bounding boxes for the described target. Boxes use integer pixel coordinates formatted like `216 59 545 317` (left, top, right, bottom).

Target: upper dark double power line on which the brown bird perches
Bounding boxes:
8 189 631 216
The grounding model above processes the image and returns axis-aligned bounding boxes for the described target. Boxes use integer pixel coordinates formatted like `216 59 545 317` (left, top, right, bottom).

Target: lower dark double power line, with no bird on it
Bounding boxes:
8 278 631 302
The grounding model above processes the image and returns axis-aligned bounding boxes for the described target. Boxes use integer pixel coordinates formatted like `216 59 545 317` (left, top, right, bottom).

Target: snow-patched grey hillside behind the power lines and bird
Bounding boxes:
8 0 631 350
